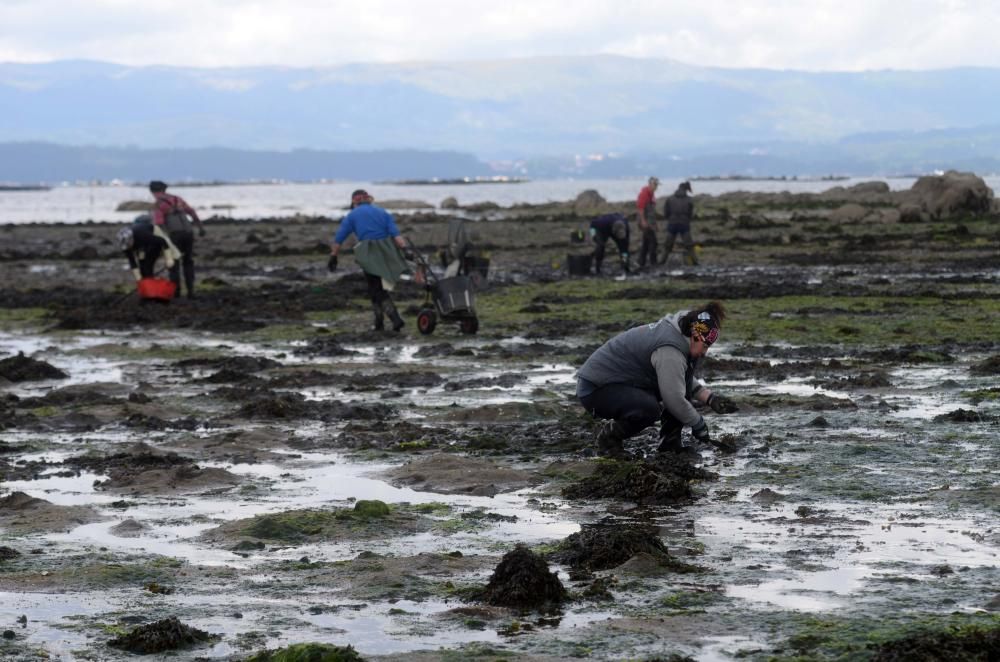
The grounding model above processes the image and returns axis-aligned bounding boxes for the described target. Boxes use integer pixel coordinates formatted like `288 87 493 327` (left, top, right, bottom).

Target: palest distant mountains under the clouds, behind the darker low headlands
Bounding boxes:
7 55 1000 159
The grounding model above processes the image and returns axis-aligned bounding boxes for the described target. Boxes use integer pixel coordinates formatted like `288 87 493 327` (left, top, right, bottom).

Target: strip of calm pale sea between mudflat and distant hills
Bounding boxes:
0 176 1000 224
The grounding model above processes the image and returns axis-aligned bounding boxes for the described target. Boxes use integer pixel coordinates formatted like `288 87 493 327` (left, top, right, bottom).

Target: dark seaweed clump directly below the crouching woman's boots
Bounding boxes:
562 455 717 504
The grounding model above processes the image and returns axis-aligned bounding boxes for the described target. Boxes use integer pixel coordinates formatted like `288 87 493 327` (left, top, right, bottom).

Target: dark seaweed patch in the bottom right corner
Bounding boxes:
872 626 1000 662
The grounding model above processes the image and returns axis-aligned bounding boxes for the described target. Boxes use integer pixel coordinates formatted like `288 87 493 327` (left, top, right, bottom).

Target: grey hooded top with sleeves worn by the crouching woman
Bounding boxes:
576 310 704 427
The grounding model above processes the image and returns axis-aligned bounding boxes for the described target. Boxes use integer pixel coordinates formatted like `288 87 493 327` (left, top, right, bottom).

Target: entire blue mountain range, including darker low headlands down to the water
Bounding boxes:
0 55 1000 181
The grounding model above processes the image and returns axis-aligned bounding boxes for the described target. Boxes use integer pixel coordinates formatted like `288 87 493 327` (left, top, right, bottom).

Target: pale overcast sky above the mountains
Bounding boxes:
0 0 1000 71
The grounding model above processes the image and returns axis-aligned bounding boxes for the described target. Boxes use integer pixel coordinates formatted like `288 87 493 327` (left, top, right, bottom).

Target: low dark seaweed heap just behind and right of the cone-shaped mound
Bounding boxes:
549 522 696 572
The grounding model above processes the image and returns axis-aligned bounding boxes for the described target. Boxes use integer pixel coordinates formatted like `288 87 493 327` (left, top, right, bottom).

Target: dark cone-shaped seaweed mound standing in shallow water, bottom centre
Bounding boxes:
481 545 568 609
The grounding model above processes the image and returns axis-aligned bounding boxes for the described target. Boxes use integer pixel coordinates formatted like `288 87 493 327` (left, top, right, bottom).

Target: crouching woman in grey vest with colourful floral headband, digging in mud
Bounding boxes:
576 301 737 457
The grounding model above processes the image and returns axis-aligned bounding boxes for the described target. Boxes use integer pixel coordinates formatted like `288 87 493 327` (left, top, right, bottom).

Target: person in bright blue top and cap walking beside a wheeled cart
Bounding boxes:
327 189 410 331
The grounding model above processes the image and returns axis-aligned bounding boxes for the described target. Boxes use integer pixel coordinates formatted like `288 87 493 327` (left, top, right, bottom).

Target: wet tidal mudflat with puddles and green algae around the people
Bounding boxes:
0 179 1000 660
